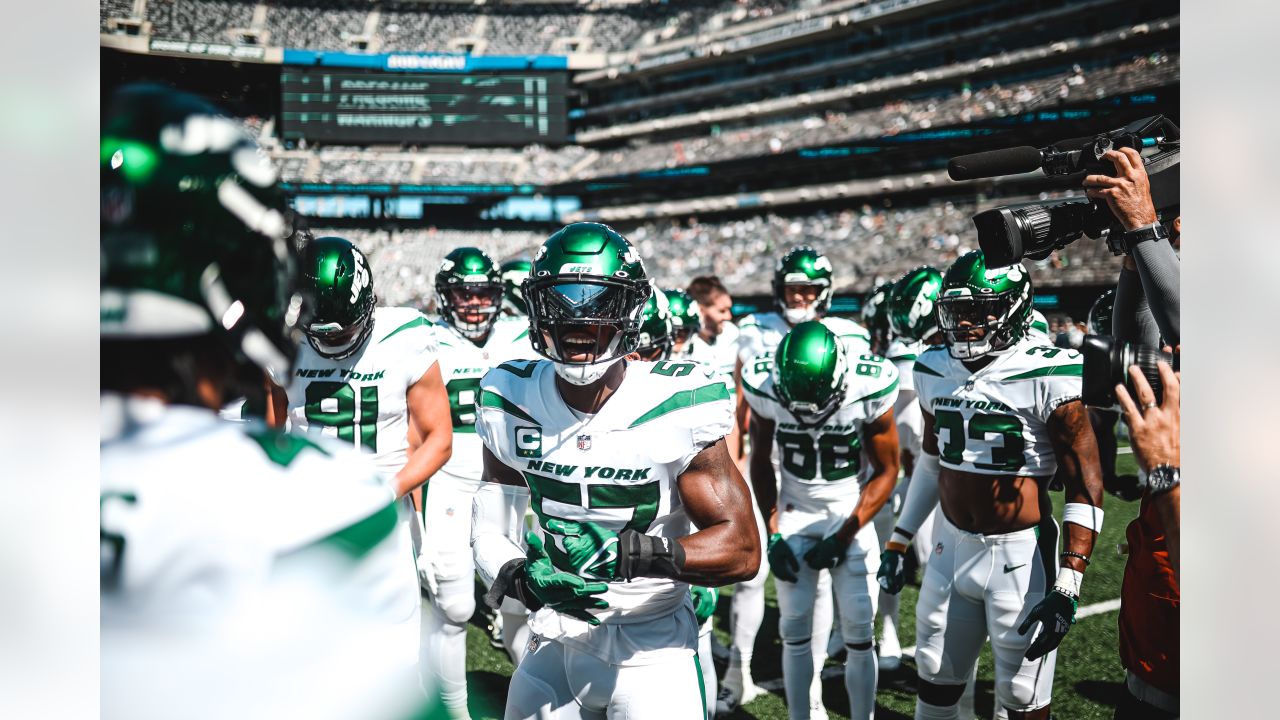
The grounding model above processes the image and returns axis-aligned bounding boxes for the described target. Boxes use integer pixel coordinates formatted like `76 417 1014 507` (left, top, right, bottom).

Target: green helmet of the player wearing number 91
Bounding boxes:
302 236 378 360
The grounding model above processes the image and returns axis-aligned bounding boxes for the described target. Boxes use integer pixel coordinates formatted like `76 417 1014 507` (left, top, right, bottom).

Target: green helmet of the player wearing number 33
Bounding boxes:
937 250 1032 360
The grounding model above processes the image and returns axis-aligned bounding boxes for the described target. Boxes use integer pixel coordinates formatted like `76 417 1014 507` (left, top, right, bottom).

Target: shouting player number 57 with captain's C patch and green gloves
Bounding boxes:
472 223 760 719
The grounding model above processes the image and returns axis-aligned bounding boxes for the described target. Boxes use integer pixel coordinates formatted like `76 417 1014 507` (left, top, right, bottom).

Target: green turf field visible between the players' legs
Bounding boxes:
467 455 1138 720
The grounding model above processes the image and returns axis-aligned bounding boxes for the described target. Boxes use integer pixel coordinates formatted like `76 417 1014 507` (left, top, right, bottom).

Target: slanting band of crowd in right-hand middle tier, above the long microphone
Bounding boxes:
582 54 1180 177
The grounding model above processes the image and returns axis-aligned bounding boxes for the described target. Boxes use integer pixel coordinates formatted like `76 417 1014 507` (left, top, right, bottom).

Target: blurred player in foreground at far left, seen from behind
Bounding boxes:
100 86 430 720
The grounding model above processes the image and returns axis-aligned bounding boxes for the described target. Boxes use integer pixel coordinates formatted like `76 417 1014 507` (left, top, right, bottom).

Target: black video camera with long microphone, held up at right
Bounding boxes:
948 115 1181 268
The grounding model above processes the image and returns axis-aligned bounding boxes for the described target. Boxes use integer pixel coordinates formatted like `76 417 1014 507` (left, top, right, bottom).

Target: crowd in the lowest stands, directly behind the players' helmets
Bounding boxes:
315 193 1120 305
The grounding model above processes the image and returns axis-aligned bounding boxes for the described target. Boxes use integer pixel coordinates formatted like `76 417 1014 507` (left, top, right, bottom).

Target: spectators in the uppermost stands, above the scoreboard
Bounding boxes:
117 0 818 55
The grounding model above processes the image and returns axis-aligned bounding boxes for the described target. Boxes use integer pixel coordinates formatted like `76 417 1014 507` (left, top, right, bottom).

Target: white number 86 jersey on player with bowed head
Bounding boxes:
742 354 899 538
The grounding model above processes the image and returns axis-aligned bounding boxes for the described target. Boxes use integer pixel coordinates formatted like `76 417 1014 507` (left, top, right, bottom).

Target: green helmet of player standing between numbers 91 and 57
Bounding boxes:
435 247 502 341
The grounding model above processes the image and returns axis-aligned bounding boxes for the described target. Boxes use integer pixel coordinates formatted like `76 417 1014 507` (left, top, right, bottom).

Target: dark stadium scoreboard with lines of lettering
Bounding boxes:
280 67 567 145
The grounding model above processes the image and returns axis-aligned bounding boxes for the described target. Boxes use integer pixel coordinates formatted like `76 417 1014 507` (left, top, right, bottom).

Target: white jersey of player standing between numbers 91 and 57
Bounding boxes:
435 316 538 483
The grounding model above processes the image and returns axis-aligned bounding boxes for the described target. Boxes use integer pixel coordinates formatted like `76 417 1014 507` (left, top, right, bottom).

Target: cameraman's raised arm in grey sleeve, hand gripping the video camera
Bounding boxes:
1084 147 1181 346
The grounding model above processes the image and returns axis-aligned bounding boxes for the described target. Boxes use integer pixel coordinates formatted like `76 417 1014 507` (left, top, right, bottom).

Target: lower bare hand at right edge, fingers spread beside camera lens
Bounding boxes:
1116 360 1181 471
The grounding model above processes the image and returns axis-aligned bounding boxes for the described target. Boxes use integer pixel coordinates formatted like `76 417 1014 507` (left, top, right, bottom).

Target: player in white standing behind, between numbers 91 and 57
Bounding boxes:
417 247 534 716
